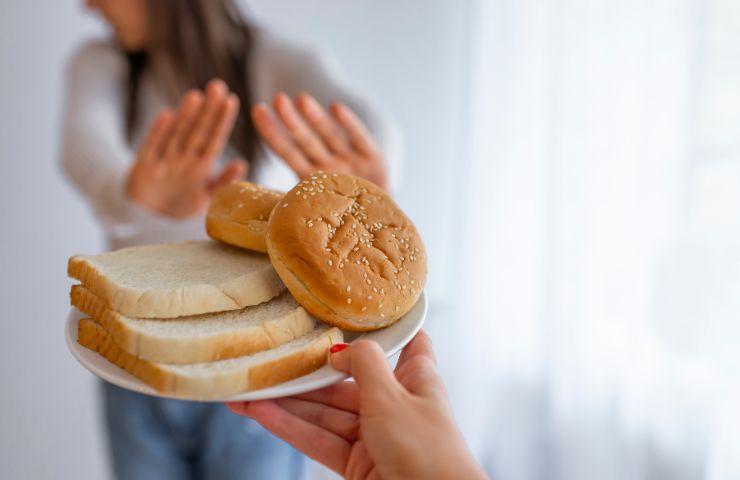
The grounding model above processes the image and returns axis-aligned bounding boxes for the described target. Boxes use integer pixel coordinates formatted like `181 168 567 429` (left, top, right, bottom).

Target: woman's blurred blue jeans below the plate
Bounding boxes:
103 382 303 480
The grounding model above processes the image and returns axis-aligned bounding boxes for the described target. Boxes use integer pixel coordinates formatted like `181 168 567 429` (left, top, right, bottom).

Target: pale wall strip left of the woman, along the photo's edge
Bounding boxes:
0 1 104 478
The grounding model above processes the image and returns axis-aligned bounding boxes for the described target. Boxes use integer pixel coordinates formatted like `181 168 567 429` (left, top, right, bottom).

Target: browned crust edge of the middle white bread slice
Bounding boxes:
70 285 315 364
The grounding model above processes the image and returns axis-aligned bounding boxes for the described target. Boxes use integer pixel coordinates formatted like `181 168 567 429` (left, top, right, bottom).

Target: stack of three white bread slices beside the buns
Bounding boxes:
68 240 342 399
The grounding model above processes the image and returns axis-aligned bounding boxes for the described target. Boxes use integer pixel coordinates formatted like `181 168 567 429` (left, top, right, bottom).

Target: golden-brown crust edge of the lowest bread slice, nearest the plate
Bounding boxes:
77 318 342 400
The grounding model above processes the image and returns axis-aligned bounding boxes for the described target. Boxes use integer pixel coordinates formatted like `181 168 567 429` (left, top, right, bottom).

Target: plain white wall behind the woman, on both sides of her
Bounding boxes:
0 0 469 479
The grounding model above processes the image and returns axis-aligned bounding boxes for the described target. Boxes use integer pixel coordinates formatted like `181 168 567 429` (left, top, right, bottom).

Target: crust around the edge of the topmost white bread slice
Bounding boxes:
67 240 285 318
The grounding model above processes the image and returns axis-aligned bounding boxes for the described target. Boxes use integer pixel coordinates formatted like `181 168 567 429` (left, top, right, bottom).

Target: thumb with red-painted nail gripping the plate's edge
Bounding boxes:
329 340 400 400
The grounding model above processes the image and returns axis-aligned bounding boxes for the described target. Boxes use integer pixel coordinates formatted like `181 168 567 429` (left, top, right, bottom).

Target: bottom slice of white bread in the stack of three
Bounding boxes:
77 319 342 400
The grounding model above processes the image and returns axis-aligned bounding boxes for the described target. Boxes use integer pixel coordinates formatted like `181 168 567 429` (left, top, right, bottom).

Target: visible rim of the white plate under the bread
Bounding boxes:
66 293 427 402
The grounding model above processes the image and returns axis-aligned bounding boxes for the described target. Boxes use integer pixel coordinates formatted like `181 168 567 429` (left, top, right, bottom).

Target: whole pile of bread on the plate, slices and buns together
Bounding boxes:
69 172 427 399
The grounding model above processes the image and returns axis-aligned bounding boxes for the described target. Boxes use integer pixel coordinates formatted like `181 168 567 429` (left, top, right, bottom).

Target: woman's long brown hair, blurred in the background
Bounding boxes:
126 0 259 167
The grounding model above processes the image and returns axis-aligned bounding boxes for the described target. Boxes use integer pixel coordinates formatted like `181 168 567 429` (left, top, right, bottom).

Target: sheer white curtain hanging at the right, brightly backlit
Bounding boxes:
450 0 740 480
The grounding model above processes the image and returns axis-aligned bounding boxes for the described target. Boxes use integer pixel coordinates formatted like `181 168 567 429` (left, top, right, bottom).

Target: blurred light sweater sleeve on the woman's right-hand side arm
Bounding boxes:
253 32 403 191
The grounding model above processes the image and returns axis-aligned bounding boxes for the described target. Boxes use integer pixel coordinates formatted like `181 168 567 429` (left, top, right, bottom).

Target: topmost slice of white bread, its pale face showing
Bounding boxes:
67 240 285 318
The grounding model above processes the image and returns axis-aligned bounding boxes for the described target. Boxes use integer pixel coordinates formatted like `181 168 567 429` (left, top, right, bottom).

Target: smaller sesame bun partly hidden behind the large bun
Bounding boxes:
206 182 283 253
